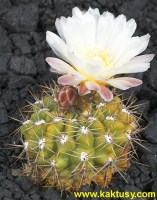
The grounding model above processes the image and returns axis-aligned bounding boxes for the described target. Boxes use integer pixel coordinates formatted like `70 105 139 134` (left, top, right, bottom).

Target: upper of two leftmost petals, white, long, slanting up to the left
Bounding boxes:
46 31 69 62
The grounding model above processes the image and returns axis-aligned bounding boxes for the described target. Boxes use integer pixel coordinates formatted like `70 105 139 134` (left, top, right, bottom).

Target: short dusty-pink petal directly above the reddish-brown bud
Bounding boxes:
58 75 80 86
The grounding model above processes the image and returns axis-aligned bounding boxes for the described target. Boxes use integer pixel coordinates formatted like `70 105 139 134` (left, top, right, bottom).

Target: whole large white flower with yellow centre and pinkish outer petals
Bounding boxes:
46 7 154 101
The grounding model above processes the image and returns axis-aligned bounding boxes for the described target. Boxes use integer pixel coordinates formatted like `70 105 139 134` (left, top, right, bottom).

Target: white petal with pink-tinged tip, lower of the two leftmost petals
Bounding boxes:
46 57 75 74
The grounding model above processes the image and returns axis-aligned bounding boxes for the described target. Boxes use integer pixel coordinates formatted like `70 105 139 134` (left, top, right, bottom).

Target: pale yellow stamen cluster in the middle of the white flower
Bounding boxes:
82 46 113 68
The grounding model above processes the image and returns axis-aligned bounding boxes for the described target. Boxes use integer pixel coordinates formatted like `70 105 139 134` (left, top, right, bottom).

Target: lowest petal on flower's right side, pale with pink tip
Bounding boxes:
106 77 142 90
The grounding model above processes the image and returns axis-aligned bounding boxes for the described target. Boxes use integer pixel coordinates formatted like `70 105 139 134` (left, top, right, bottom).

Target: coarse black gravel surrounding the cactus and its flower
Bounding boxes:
0 0 157 200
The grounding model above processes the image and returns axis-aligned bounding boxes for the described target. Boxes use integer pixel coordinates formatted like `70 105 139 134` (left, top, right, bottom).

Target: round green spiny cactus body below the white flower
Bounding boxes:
20 86 139 191
